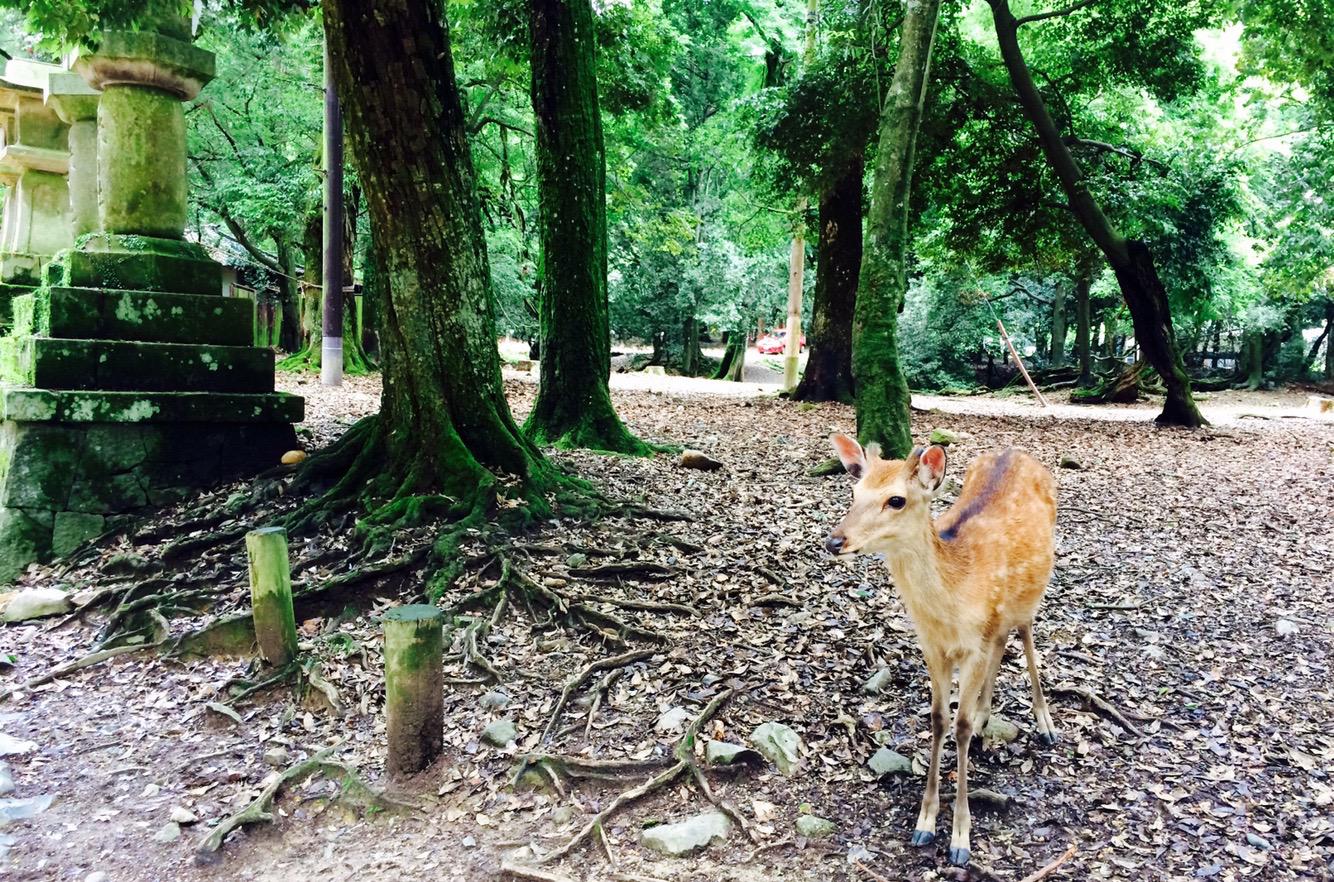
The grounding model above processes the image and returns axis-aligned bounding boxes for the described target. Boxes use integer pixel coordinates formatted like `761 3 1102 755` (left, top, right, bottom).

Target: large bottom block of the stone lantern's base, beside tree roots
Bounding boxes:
0 416 299 582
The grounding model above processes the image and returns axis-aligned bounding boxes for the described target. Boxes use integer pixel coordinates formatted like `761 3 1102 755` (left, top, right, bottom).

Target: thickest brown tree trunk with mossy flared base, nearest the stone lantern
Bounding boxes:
321 0 554 511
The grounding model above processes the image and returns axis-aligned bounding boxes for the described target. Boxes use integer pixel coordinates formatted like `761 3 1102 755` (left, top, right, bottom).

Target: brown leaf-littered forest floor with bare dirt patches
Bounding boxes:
0 372 1334 882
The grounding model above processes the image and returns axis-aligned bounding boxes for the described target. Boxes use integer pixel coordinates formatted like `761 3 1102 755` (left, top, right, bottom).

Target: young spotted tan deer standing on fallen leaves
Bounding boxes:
824 435 1057 866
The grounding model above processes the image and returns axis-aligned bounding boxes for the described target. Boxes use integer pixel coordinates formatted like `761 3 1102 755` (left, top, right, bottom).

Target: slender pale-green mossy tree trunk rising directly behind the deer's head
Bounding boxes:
852 0 940 456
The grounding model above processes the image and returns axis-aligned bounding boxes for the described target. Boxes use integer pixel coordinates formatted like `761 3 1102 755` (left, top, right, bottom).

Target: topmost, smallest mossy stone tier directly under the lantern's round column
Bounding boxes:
44 234 223 295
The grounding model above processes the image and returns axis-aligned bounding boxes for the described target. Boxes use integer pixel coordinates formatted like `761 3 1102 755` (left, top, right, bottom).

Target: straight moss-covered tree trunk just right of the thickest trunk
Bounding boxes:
524 0 648 454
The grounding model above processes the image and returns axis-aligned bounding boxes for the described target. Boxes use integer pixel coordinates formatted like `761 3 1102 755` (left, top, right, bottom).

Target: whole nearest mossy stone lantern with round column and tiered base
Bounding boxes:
0 21 304 582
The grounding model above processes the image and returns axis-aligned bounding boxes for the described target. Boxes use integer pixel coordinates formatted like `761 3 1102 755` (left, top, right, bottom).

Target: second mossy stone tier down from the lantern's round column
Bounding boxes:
13 288 255 346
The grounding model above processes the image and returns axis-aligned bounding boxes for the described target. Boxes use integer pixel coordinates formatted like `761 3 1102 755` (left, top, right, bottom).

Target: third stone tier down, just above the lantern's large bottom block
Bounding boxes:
0 336 273 392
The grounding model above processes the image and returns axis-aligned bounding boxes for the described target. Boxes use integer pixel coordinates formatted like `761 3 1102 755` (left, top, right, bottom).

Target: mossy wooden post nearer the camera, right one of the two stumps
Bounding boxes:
384 603 444 775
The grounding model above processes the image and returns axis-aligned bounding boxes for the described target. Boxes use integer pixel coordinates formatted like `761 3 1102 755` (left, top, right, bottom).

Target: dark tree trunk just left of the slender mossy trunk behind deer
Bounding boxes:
792 156 864 402
